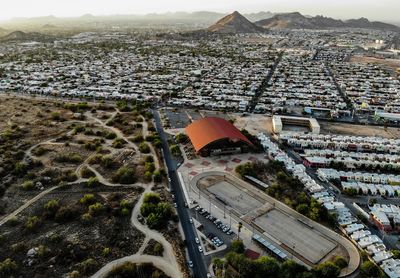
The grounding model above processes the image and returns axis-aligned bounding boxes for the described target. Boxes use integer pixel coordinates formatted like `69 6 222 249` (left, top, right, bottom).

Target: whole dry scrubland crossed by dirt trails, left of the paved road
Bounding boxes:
0 95 187 277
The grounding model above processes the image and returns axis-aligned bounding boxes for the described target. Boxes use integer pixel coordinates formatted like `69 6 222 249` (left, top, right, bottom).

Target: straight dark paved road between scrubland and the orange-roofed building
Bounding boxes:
152 110 207 278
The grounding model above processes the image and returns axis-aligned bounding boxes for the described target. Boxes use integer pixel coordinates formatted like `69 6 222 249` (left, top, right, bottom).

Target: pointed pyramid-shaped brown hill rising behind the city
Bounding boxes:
208 12 265 33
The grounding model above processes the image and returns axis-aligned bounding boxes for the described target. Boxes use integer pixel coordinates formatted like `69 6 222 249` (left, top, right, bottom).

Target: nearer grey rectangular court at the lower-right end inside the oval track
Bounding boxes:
255 209 337 264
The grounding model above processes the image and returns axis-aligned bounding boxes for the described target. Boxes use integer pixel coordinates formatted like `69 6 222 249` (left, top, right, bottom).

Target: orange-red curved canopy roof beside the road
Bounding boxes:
185 117 252 152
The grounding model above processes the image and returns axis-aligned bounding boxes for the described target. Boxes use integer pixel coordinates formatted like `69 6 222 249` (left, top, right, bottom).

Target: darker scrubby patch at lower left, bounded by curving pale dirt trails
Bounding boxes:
0 184 144 277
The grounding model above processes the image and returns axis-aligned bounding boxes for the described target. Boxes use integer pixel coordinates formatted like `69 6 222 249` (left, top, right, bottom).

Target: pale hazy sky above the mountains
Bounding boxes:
0 0 400 21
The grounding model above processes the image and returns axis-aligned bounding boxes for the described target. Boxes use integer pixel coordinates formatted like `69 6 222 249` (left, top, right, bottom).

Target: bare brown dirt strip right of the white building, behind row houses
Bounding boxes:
319 121 400 139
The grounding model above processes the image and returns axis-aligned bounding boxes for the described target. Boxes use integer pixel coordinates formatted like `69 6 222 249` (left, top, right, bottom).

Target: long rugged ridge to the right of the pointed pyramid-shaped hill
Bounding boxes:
255 12 400 31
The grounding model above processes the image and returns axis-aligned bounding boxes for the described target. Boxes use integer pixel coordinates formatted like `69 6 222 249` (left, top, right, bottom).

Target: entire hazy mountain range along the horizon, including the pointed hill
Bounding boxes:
0 11 400 41
